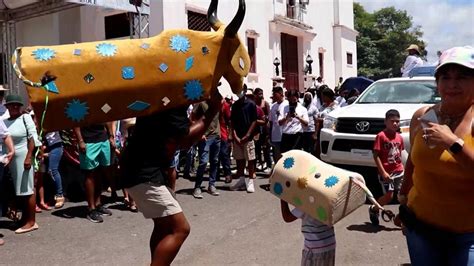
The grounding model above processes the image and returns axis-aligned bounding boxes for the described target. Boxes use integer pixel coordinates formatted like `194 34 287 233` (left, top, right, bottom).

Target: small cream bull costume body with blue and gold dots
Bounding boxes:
270 150 366 225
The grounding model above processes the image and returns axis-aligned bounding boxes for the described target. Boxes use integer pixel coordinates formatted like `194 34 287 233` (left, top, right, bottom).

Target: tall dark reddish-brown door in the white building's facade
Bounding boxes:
281 33 299 90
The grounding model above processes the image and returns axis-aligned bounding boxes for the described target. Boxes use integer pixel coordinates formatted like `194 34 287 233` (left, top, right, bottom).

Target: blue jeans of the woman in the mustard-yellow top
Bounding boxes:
406 229 474 266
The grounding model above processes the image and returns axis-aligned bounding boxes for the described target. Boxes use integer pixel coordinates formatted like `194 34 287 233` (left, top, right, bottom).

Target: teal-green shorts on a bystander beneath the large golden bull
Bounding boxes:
79 140 110 170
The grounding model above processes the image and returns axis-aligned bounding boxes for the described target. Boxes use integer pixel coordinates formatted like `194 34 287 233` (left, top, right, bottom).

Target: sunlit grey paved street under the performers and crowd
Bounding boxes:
0 174 409 265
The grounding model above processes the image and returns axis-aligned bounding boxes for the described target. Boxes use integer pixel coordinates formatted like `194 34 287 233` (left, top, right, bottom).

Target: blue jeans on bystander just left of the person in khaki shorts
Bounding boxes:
194 136 221 188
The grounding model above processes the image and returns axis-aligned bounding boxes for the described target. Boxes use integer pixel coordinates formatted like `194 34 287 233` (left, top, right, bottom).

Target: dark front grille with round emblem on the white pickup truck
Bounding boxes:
336 118 385 134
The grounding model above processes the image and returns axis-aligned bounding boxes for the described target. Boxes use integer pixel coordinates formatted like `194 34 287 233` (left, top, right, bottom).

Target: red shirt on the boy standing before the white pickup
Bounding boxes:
374 130 405 174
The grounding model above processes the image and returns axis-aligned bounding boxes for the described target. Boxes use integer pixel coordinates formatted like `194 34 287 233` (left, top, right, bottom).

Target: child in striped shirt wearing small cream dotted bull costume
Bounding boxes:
270 150 394 266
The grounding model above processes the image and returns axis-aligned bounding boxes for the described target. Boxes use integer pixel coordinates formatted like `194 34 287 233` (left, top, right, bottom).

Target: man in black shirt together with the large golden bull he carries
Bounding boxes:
12 0 250 265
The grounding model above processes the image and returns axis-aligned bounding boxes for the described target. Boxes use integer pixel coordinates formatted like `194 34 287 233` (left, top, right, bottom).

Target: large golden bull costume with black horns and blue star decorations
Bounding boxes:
13 0 250 131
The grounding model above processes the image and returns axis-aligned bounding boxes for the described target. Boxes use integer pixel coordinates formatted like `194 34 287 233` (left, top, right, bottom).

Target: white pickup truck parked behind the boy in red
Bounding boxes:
320 77 441 166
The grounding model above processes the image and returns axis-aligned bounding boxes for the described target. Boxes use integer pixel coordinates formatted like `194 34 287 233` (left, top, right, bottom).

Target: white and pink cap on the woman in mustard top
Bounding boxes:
435 46 474 75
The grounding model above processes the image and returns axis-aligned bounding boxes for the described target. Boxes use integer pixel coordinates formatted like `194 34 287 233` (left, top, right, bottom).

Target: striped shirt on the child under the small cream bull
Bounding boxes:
291 208 336 253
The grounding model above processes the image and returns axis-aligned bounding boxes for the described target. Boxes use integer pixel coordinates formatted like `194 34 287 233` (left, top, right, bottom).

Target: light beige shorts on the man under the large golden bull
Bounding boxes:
127 182 183 219
